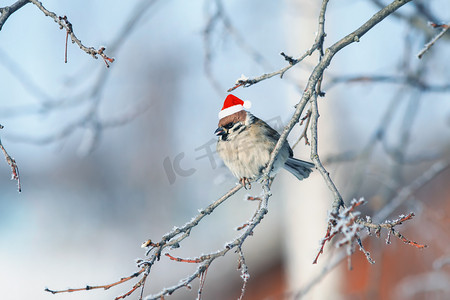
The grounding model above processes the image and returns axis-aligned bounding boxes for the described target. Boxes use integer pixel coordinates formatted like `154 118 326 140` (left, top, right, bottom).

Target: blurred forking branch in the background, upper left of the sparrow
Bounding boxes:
0 0 158 154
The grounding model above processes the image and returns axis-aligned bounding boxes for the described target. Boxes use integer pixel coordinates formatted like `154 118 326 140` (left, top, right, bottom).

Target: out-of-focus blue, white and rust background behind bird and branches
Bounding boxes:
0 0 450 300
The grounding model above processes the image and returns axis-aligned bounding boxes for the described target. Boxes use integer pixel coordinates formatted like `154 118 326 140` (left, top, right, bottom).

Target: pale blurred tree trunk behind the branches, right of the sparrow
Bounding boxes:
283 0 340 299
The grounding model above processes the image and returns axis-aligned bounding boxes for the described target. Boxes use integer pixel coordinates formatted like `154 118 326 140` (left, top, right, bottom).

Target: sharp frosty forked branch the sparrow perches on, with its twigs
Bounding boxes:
44 0 432 299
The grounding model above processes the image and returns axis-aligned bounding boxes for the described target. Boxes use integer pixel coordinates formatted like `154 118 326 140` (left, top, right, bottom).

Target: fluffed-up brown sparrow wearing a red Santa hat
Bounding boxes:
215 94 314 189
